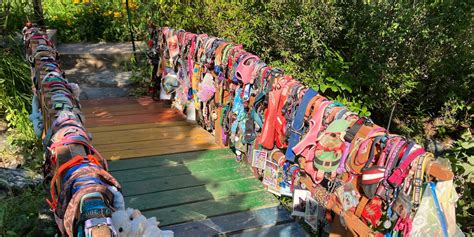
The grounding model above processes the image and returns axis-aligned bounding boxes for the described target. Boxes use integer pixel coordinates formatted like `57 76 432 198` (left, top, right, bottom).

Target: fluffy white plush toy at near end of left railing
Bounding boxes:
112 208 174 237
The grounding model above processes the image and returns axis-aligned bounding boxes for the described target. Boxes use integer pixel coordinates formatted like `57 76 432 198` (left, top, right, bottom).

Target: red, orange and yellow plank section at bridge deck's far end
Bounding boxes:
81 97 219 160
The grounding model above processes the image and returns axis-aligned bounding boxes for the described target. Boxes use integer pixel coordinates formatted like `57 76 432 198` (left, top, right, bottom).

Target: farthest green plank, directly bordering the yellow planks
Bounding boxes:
109 148 235 171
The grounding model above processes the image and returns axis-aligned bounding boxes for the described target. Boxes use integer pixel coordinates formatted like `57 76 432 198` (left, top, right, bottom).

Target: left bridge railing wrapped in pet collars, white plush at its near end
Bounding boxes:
23 25 173 236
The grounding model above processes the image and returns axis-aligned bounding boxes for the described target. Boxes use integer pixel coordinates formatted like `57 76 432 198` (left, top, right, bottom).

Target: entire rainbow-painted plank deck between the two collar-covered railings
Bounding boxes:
81 97 306 236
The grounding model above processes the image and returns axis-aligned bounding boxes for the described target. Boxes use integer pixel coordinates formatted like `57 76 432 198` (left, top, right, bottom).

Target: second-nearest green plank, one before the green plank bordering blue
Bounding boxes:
125 177 263 211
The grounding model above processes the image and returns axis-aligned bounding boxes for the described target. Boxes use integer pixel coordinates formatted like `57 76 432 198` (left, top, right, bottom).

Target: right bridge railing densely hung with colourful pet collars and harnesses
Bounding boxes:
148 26 453 236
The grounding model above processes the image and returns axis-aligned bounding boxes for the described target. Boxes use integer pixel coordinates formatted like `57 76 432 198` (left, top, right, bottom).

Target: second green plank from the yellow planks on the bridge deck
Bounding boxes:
112 157 241 184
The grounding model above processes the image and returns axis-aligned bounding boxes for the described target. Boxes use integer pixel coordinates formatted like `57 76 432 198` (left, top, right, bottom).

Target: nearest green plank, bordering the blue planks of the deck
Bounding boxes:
142 191 279 226
